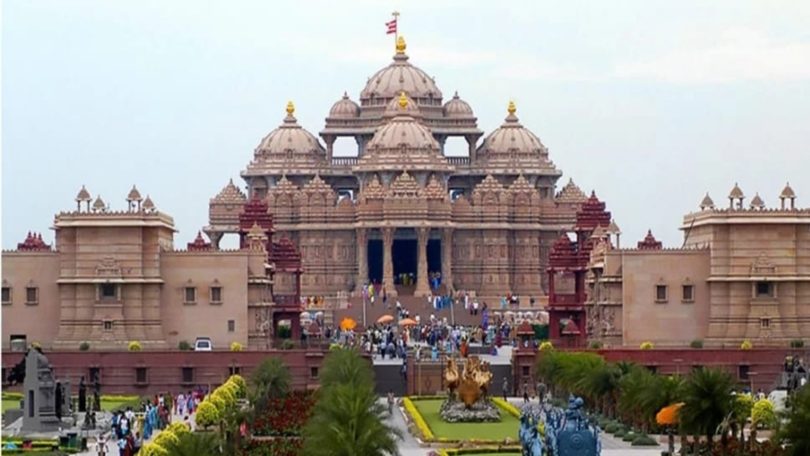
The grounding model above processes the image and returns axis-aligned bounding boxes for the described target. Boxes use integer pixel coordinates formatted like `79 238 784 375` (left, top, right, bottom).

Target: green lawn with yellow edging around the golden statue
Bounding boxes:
413 399 520 442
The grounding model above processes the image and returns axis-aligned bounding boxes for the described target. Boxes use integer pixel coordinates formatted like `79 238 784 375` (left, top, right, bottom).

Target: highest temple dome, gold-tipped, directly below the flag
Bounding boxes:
360 37 442 105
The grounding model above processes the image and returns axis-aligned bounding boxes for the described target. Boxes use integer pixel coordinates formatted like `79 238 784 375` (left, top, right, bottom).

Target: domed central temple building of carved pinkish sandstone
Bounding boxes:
205 40 586 297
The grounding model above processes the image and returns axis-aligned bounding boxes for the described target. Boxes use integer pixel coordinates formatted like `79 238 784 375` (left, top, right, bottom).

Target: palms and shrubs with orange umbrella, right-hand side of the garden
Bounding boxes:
537 349 810 456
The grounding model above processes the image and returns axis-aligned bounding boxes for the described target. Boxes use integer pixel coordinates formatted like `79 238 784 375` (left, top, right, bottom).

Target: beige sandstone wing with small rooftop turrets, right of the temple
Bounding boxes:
586 184 810 347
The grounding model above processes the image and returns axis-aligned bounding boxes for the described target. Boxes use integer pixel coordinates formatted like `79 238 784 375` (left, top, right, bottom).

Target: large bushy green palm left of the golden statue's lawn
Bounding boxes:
302 349 401 456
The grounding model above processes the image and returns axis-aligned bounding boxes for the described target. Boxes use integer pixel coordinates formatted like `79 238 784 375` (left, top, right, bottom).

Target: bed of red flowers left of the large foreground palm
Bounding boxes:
250 391 315 436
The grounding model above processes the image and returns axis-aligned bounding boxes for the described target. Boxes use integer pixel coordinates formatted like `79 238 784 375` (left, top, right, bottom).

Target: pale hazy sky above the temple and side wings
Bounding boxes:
2 0 810 248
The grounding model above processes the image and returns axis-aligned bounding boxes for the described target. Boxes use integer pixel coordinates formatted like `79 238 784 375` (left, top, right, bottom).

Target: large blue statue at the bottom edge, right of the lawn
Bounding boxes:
546 396 602 456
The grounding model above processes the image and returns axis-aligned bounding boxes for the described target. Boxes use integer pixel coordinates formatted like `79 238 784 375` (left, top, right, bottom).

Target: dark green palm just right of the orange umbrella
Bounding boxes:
679 367 734 446
